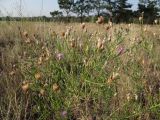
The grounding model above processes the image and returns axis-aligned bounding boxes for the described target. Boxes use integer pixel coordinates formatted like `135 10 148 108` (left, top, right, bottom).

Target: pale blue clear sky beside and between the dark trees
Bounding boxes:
0 0 138 17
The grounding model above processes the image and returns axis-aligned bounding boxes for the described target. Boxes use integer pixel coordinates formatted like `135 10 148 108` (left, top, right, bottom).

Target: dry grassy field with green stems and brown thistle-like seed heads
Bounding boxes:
0 22 160 120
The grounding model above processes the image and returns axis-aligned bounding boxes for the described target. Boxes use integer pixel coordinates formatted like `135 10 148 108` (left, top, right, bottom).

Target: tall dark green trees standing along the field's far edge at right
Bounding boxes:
50 0 160 23
